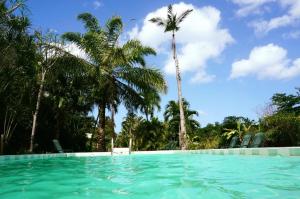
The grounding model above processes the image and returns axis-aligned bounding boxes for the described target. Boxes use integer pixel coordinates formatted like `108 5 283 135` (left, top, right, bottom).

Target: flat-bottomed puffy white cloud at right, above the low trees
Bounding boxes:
230 44 300 79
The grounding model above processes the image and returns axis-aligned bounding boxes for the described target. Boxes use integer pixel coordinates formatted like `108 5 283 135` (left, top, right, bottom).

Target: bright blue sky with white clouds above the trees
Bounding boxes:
27 0 300 132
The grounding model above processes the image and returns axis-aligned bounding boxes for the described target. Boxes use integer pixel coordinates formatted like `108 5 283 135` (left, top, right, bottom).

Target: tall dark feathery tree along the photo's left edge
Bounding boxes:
0 0 36 153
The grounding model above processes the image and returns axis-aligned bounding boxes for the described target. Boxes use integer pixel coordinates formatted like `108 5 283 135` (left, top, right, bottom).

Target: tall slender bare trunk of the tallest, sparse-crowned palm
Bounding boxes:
172 32 186 150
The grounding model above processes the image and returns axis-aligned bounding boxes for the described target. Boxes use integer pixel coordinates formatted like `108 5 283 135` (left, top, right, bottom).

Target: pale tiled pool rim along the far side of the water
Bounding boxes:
0 147 300 161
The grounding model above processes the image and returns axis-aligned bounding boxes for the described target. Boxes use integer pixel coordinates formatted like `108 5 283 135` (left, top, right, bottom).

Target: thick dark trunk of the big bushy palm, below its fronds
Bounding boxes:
97 103 106 152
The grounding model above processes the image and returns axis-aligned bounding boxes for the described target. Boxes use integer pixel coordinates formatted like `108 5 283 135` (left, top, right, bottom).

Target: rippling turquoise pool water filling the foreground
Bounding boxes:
0 154 300 199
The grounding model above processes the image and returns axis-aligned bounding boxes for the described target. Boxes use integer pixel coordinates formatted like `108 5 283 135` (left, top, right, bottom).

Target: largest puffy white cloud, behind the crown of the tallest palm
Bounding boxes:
128 2 233 83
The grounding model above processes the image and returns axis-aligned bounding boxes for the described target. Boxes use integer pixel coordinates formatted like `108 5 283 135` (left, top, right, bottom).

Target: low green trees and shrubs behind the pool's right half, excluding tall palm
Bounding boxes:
117 88 300 150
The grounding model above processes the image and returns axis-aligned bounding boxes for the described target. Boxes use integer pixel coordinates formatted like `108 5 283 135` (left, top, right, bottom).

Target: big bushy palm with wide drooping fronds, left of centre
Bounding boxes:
63 13 166 151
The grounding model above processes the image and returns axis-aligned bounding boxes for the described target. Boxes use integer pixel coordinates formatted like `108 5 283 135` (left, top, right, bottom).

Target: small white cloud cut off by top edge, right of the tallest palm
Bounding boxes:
232 0 276 17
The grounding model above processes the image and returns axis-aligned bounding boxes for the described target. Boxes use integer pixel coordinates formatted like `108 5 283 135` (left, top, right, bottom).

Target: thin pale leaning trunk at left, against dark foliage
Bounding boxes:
29 71 46 153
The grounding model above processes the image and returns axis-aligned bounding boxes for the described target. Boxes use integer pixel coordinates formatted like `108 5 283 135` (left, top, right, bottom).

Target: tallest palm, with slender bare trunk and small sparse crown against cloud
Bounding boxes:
150 5 193 150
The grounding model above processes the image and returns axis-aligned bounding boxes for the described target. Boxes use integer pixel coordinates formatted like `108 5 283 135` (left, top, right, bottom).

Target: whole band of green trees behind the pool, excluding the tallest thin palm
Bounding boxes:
0 0 300 154
